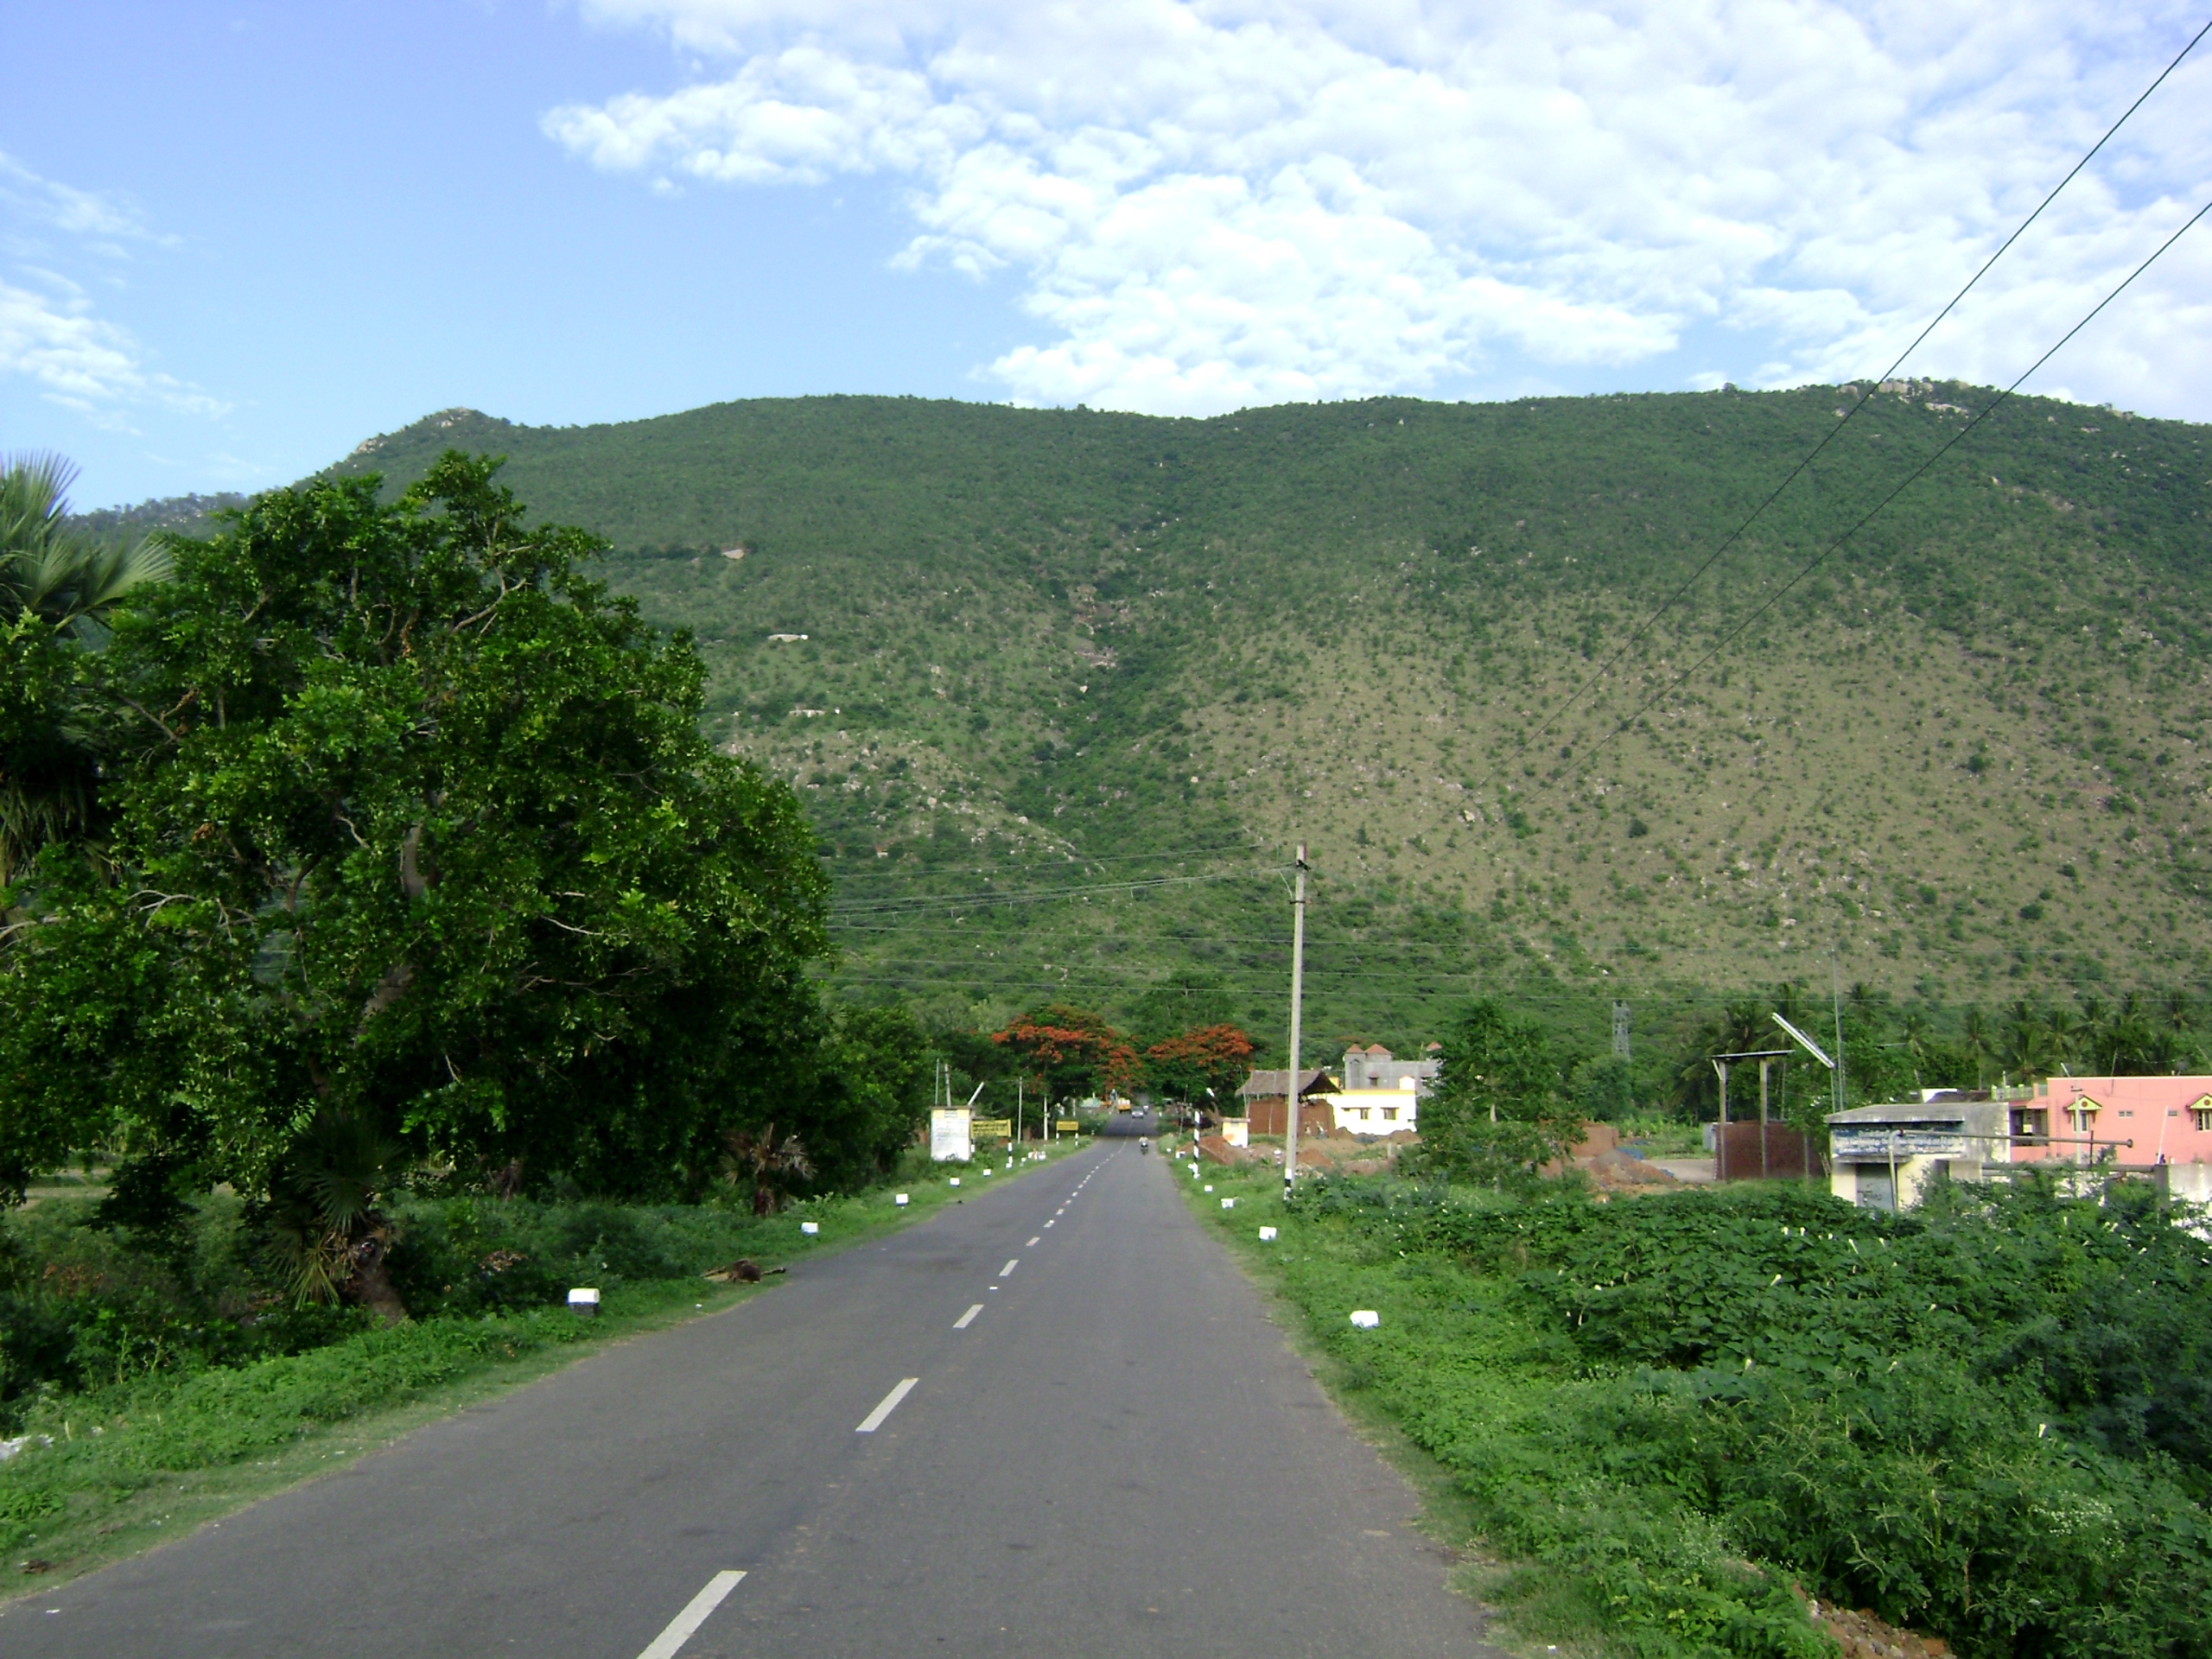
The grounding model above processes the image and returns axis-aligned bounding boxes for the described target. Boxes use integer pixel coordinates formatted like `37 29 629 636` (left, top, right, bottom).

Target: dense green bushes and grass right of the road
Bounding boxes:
1199 1174 2212 1659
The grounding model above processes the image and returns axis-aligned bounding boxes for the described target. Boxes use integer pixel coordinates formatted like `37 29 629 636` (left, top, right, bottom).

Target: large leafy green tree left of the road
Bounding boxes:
0 454 830 1192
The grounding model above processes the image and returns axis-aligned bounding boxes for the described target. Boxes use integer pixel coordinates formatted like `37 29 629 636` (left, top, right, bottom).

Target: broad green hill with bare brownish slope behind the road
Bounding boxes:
322 383 2212 1044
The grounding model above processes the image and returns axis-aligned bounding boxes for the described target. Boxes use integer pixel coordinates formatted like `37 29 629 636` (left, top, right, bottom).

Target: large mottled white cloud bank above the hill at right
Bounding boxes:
544 0 2212 416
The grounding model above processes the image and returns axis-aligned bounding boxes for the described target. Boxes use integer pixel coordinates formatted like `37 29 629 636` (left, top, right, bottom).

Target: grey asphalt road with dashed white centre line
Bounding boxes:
0 1139 1491 1659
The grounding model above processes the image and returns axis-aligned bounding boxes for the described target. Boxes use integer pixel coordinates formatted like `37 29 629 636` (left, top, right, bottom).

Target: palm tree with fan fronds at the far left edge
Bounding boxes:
0 454 170 887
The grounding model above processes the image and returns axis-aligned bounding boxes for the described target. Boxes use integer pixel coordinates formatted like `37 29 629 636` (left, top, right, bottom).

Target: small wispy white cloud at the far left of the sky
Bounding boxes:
0 153 230 429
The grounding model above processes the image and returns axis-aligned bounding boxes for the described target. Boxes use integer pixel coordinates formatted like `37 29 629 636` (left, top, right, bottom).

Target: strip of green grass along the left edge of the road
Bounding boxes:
0 1141 1086 1601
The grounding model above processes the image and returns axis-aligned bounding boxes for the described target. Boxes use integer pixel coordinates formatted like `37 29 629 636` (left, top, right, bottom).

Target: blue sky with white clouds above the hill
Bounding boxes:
0 0 2212 506
